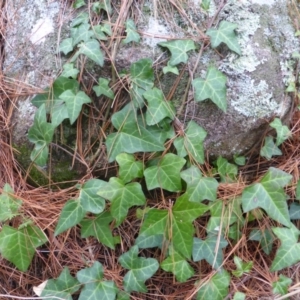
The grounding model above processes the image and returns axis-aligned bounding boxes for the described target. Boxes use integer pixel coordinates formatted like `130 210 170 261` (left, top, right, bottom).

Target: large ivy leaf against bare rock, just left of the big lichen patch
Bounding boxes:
192 67 227 112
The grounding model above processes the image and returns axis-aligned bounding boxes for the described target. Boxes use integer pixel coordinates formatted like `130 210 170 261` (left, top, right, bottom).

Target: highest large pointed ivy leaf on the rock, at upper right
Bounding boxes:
206 21 241 55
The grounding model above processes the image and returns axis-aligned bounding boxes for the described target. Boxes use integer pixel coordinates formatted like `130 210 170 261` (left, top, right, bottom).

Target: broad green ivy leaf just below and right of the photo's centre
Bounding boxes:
144 153 186 192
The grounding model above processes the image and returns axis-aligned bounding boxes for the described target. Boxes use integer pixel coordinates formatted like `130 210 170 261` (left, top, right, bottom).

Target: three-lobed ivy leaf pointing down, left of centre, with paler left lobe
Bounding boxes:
98 177 146 226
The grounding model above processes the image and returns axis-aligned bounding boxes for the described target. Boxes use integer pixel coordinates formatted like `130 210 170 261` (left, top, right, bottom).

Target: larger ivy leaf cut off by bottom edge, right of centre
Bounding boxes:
197 270 230 300
